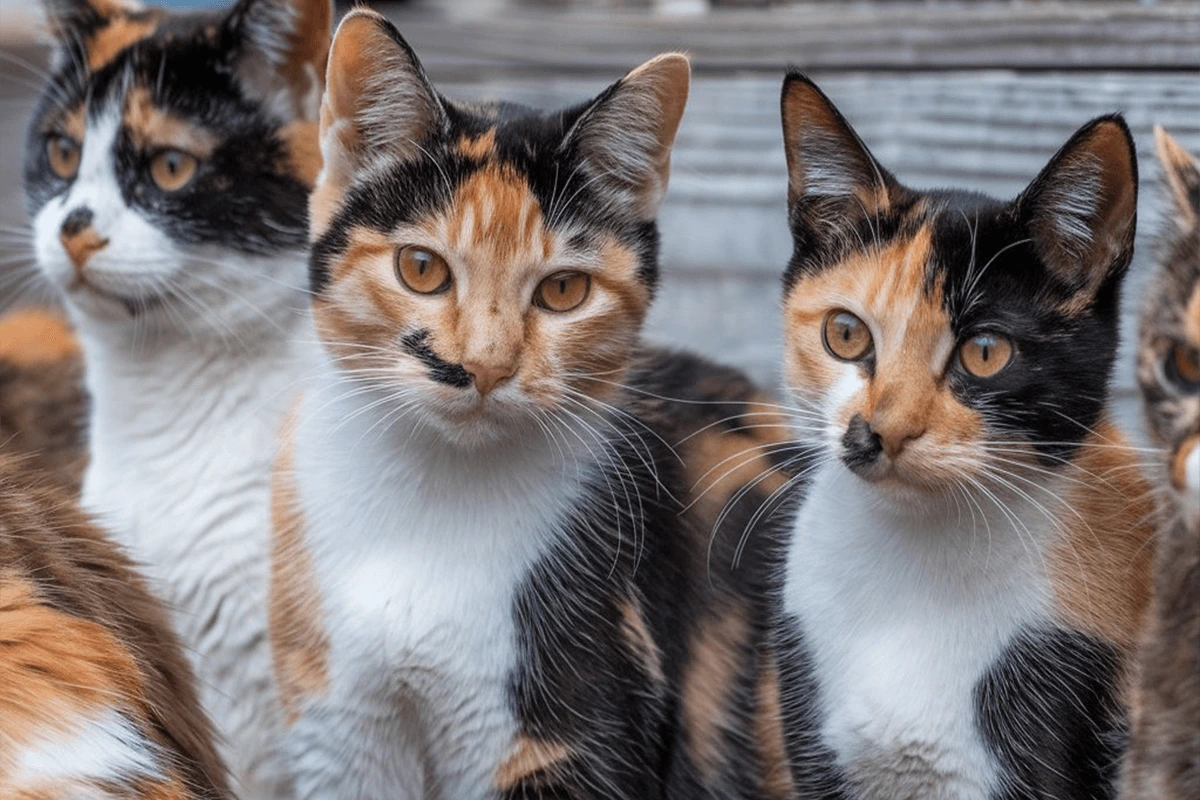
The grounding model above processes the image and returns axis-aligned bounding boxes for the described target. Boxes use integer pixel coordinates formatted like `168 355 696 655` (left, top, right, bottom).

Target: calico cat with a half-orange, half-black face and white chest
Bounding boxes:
779 73 1153 800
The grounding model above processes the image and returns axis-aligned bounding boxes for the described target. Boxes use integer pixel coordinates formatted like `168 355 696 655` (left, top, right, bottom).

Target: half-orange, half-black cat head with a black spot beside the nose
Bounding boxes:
782 73 1138 494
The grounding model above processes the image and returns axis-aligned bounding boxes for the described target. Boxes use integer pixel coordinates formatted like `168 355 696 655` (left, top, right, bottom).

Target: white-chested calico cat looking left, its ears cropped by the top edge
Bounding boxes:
25 0 332 799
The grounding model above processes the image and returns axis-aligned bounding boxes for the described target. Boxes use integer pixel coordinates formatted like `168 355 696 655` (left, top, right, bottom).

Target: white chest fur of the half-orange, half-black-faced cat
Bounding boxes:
784 464 1051 800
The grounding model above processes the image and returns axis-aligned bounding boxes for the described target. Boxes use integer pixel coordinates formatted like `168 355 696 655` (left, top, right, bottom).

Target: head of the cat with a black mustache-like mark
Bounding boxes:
310 11 689 444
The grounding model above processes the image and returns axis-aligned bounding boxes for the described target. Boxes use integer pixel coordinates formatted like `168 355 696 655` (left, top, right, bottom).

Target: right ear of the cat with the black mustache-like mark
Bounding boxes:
560 53 691 222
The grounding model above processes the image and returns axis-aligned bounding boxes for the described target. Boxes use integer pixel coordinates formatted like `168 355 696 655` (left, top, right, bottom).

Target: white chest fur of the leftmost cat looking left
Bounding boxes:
82 317 313 800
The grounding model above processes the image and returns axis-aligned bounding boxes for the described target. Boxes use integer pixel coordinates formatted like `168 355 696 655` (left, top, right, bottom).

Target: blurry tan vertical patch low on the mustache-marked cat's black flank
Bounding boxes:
680 608 749 781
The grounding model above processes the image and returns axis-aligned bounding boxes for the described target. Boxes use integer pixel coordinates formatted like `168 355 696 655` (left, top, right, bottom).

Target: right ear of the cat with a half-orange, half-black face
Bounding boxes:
1016 115 1138 303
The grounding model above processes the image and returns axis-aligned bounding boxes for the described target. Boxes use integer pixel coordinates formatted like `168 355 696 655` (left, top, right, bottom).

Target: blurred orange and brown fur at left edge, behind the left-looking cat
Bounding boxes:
0 308 88 497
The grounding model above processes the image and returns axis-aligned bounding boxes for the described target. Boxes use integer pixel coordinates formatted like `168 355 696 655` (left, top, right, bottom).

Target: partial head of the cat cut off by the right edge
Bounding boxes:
1138 128 1200 525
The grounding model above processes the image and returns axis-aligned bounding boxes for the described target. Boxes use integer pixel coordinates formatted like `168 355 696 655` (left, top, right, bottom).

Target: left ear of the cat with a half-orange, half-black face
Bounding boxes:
780 72 901 255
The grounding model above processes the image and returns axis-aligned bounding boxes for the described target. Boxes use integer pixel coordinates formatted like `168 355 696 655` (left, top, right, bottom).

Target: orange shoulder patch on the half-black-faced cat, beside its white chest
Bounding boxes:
1048 422 1154 650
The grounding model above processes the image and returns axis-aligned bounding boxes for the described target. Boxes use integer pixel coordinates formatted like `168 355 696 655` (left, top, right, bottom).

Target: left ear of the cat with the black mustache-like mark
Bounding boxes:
310 8 449 236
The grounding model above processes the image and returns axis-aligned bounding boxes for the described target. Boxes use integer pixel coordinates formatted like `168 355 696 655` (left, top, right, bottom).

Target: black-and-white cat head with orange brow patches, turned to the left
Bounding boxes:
24 0 332 332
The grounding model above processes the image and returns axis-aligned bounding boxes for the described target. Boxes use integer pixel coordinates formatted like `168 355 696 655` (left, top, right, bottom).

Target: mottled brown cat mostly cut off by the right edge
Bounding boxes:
1123 128 1200 800
